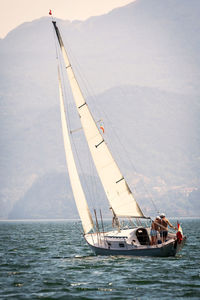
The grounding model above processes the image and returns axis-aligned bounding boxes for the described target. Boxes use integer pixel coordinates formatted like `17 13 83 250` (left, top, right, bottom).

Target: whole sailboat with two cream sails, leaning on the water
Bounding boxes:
52 20 186 257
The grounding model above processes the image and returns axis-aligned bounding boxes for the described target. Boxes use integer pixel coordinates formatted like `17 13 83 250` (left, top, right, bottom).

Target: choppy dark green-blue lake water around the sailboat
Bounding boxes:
0 219 200 299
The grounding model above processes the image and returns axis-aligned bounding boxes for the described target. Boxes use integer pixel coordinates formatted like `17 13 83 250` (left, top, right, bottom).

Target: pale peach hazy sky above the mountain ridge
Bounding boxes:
0 0 134 38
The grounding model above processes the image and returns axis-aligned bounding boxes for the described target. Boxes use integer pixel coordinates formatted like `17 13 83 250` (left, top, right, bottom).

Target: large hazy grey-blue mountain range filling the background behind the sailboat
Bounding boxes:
0 0 200 218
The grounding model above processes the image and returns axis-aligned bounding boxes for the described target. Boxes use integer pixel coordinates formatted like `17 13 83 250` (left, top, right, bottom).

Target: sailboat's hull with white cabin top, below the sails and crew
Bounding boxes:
85 228 186 257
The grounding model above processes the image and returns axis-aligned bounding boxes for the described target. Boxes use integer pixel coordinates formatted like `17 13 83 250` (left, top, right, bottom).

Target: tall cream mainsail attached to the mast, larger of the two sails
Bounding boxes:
53 22 144 217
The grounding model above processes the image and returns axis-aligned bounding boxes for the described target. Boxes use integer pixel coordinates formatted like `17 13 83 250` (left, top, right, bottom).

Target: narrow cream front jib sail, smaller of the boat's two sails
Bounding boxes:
58 69 94 233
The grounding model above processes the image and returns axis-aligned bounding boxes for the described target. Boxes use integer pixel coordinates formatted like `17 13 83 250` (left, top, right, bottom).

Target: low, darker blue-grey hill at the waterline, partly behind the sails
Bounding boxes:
8 172 109 219
